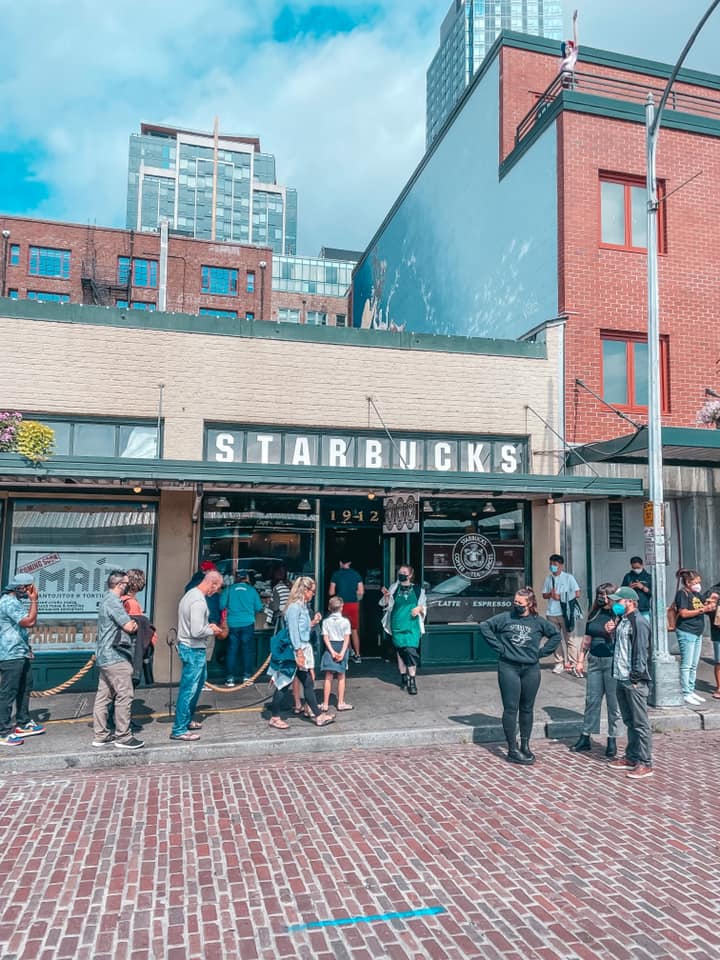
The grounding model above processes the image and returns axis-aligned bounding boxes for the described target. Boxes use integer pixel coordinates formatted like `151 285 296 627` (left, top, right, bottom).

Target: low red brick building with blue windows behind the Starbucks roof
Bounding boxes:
0 216 347 326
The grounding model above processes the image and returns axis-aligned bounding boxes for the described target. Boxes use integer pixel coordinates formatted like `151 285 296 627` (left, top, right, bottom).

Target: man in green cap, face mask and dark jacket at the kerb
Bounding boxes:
608 587 653 780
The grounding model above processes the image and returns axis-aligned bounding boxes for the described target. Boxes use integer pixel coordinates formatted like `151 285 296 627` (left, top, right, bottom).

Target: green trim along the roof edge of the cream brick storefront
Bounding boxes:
0 299 547 360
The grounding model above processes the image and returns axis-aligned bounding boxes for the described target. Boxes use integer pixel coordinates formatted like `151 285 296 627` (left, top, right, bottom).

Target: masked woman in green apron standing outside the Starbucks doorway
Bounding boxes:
380 563 427 696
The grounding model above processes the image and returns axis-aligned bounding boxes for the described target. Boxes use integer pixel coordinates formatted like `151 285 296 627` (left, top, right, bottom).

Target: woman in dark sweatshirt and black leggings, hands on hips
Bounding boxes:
480 587 560 764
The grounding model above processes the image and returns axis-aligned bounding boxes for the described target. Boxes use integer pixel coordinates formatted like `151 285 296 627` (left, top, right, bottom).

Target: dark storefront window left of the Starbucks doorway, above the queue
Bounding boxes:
201 494 317 599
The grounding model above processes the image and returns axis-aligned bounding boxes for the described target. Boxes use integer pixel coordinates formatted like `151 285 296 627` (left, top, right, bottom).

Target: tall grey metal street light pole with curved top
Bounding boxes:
645 0 720 707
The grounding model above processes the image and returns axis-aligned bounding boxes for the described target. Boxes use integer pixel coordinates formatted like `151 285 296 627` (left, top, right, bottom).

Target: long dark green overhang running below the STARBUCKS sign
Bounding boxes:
0 454 643 500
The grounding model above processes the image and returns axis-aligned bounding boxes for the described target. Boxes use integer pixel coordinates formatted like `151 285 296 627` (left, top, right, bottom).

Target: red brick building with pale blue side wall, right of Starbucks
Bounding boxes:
352 33 720 596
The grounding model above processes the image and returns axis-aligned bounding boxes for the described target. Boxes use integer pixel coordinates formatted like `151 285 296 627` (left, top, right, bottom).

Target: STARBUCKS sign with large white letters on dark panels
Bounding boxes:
205 427 527 473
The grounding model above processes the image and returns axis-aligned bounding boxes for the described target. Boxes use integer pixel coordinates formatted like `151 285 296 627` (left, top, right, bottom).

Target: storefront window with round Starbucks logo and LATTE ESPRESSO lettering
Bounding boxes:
423 499 527 623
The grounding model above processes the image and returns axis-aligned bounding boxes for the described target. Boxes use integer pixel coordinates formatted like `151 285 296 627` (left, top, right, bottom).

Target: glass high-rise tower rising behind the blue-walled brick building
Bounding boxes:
425 0 562 147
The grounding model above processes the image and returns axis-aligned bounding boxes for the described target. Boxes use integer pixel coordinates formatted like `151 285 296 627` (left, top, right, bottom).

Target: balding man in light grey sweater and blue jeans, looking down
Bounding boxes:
170 570 223 740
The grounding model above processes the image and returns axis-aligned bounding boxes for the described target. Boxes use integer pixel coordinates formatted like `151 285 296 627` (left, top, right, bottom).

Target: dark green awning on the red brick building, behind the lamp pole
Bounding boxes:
567 427 720 467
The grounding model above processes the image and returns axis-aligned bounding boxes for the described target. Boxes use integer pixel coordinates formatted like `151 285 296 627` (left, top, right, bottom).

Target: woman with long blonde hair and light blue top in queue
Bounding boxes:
270 577 335 730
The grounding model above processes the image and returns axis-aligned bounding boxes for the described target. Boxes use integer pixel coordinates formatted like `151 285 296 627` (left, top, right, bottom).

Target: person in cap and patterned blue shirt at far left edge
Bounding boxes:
0 573 45 747
